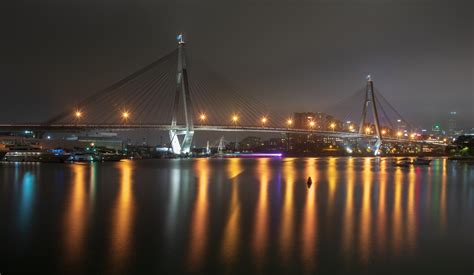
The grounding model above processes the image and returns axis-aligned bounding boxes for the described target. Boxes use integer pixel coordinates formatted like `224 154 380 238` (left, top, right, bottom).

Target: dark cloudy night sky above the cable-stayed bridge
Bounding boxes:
0 0 474 128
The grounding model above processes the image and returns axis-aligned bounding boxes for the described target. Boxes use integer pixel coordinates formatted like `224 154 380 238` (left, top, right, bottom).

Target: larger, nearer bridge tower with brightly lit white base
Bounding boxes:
169 34 194 155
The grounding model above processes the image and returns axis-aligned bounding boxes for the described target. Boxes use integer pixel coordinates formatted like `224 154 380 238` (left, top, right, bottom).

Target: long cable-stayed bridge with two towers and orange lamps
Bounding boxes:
0 35 444 154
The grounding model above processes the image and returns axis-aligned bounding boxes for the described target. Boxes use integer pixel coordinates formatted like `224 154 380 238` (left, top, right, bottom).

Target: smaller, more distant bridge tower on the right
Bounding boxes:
359 75 382 155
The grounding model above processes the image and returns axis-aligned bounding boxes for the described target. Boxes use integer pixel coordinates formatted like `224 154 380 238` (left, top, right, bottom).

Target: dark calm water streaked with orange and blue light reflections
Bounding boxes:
0 158 474 274
